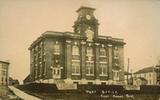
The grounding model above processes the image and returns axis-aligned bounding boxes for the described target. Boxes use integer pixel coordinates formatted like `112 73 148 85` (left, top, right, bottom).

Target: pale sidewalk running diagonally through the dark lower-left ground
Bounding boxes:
9 86 41 100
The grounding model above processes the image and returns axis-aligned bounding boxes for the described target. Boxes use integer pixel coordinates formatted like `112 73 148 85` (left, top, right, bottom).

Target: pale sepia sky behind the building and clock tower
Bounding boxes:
0 0 160 81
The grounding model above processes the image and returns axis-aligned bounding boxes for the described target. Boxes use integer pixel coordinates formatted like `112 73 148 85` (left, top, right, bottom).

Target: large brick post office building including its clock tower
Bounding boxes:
29 7 125 84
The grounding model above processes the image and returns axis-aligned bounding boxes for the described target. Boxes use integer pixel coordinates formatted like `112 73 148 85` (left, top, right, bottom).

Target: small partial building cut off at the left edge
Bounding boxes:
0 61 9 85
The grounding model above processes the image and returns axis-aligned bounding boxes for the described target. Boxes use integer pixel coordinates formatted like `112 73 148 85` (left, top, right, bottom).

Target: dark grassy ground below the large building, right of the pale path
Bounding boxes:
18 84 160 100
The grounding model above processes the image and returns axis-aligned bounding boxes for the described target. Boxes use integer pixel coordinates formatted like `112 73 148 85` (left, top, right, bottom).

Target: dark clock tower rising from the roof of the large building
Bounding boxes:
73 7 99 41
